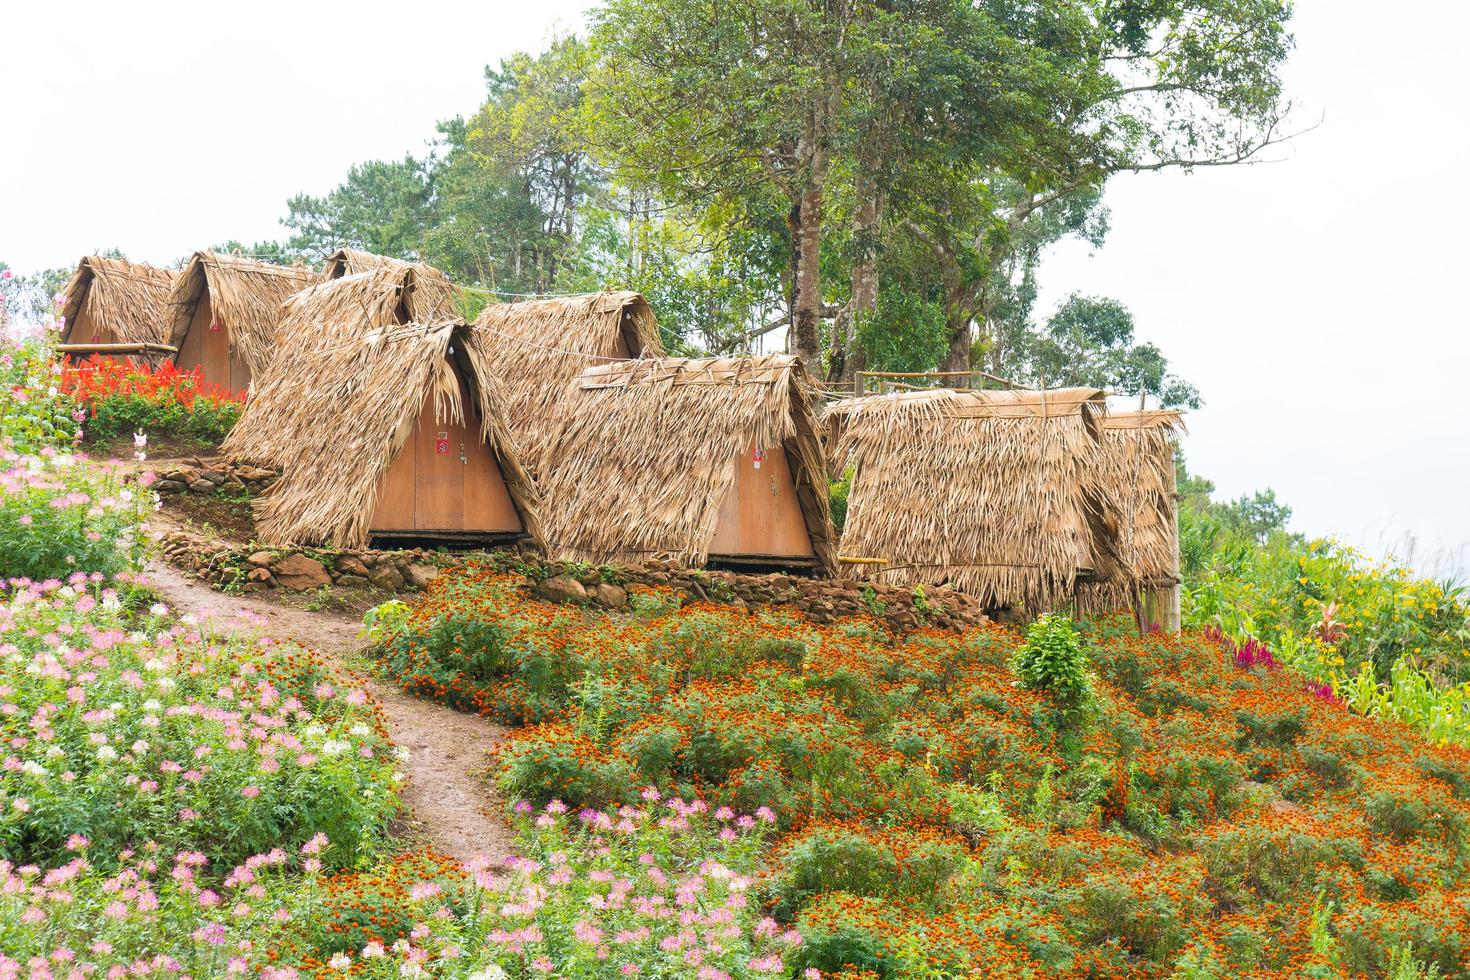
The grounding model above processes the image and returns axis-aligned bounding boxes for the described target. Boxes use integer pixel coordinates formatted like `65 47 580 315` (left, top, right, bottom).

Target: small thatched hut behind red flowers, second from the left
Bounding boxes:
168 251 320 391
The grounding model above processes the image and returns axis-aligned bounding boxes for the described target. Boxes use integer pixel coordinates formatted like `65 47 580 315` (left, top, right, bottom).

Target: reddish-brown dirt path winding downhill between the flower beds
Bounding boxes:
147 560 513 868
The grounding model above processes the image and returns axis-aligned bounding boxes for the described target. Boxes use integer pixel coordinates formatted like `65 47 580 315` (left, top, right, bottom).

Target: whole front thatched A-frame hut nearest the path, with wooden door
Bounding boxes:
225 315 542 548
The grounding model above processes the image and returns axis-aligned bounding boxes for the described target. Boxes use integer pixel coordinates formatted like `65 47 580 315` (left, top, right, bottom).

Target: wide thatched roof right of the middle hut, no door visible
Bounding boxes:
828 388 1120 611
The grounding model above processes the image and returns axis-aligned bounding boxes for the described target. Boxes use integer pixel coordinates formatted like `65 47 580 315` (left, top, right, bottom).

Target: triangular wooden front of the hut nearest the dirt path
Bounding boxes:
369 370 523 539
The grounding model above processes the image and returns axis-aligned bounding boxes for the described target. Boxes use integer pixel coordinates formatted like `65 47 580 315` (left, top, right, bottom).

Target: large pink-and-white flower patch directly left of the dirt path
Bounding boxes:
0 573 397 864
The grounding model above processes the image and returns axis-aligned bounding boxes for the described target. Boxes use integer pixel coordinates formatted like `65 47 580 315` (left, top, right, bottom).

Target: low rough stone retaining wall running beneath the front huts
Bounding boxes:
163 532 988 630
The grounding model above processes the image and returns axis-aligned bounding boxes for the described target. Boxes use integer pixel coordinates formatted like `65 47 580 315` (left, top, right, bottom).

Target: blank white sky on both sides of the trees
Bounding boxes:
0 0 1470 572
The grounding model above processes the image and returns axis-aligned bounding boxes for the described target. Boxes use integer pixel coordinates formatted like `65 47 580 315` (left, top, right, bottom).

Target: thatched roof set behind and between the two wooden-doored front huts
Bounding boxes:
475 292 663 473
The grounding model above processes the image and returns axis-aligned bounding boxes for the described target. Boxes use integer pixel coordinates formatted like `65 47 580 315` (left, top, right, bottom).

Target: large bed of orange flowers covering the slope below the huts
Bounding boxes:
373 573 1470 977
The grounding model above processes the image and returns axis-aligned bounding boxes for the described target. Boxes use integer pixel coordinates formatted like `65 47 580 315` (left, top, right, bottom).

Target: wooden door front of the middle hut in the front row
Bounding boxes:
709 445 816 563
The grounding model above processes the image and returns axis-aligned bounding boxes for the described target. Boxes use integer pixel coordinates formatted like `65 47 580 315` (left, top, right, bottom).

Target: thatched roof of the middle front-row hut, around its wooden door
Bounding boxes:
539 354 833 570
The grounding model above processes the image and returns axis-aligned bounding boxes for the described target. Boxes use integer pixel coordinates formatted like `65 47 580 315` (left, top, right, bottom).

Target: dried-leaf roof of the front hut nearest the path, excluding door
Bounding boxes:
223 315 542 548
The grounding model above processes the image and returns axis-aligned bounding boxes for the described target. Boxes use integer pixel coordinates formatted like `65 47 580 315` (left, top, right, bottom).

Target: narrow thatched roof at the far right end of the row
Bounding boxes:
1100 410 1183 585
